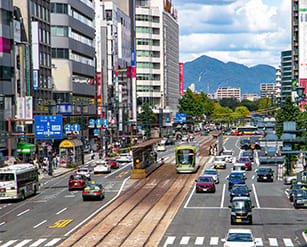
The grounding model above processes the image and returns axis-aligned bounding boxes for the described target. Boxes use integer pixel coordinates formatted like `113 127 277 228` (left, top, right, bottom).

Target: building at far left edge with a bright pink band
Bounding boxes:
0 0 15 158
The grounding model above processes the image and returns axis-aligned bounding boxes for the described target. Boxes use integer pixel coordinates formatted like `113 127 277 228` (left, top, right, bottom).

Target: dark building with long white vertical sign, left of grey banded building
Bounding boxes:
14 0 53 114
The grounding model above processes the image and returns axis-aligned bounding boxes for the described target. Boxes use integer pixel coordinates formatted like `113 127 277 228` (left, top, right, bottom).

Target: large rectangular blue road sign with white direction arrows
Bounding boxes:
34 115 63 139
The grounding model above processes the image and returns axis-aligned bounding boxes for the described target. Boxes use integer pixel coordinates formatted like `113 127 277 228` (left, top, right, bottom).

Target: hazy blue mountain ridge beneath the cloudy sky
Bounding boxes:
183 56 276 95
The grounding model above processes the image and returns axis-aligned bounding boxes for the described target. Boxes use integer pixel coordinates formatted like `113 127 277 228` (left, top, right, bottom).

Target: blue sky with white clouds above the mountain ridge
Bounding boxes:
172 0 291 68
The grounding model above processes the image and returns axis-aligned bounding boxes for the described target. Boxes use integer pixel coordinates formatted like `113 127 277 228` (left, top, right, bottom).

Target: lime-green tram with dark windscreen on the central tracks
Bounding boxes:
175 143 199 173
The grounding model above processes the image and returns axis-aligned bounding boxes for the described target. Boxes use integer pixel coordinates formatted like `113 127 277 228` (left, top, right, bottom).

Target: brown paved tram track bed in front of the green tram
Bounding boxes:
60 159 202 246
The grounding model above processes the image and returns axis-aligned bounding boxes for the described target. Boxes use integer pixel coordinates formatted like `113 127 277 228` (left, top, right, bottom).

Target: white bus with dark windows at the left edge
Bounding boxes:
0 164 40 200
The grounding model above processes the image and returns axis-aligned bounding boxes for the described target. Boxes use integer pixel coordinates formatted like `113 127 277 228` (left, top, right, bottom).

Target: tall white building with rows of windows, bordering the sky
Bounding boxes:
135 0 179 118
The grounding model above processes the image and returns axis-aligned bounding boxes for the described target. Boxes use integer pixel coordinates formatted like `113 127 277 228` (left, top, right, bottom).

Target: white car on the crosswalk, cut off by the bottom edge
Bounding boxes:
222 228 256 247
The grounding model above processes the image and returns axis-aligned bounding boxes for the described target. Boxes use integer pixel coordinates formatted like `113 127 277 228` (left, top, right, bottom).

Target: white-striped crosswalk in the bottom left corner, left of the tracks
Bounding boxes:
0 238 62 247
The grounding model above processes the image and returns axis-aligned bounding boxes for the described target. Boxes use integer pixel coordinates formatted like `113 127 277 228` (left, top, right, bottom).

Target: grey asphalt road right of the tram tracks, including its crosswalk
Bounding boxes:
159 137 307 246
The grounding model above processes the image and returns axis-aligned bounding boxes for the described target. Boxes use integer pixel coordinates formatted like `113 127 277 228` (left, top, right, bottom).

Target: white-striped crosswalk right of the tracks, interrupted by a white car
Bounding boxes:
163 236 294 247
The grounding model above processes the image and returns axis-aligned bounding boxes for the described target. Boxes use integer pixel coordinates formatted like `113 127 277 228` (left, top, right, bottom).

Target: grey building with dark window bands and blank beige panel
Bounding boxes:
51 0 96 111
